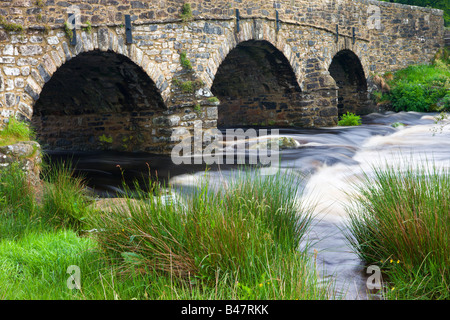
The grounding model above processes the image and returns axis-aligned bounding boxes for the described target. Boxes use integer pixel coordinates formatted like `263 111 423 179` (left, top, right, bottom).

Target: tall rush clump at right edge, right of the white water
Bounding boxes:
347 165 450 299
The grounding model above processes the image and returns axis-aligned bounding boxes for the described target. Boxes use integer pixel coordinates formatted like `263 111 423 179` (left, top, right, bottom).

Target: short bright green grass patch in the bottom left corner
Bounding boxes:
0 230 104 300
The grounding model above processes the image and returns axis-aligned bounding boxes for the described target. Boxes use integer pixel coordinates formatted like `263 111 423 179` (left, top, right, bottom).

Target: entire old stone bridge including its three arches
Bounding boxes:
0 0 444 153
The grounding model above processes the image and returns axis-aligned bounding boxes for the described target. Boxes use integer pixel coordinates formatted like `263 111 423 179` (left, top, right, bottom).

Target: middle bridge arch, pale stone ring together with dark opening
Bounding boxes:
207 19 320 127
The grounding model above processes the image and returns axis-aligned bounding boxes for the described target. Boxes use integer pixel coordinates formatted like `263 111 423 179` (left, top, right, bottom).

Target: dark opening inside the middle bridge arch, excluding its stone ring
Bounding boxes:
211 40 302 127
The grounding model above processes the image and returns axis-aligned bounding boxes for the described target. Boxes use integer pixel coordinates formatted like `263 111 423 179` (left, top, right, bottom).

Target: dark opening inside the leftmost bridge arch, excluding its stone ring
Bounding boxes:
31 50 165 152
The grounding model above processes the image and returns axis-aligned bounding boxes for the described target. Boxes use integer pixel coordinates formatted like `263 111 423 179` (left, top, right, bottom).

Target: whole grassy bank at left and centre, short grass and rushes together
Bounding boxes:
0 163 332 300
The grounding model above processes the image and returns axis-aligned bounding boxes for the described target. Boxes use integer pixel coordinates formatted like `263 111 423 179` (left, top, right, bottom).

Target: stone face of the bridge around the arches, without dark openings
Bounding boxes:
0 0 444 152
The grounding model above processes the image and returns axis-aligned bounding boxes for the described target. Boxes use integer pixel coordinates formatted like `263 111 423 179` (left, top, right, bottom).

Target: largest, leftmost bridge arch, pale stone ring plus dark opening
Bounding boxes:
25 32 170 152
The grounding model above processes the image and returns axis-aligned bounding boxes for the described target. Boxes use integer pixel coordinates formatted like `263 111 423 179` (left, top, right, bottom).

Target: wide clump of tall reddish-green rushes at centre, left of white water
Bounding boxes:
90 174 328 299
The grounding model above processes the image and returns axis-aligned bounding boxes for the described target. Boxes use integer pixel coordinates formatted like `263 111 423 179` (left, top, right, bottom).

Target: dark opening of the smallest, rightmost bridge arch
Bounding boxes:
328 50 371 116
